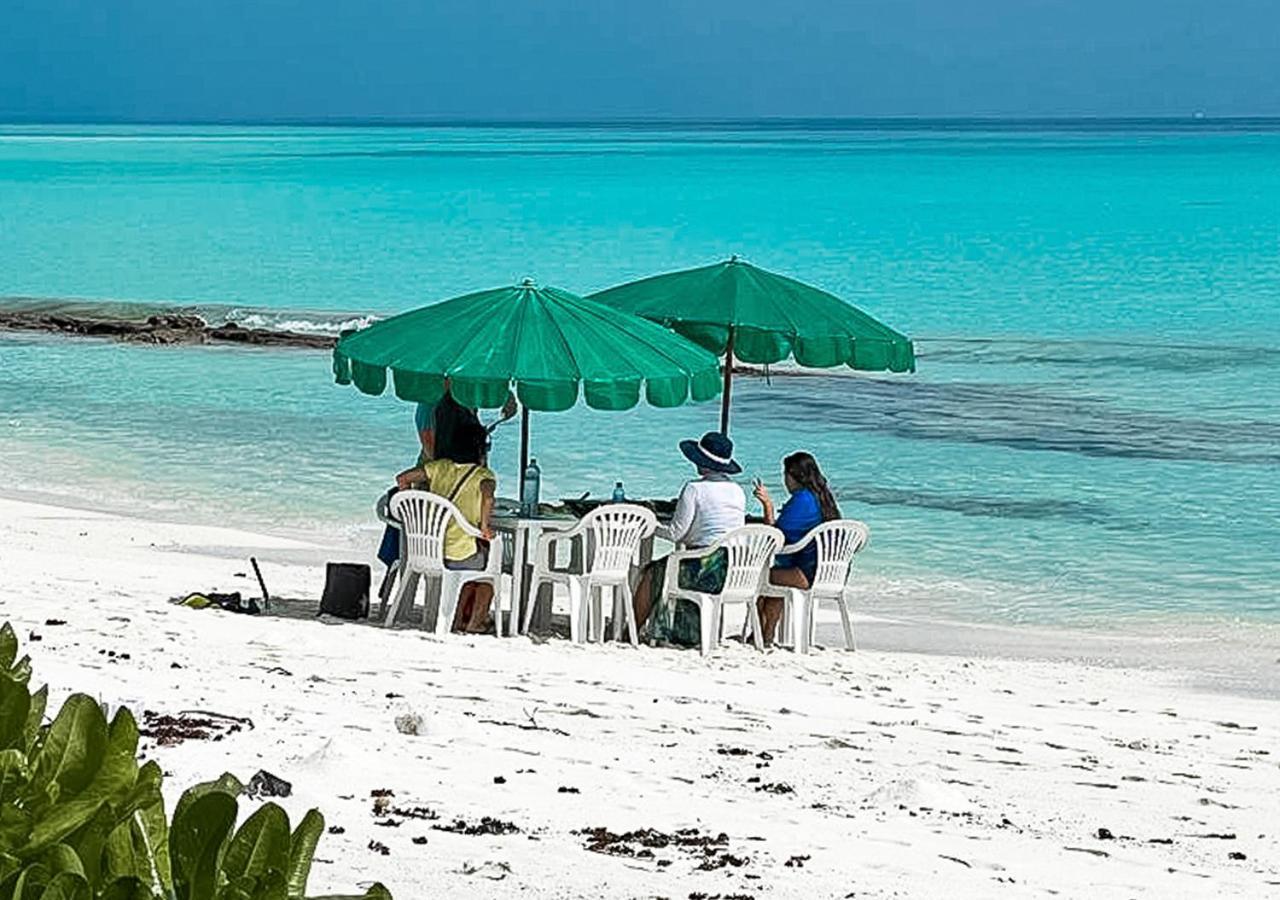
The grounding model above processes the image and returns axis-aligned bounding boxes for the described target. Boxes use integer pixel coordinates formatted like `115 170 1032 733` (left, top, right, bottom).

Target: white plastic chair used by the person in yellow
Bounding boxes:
384 490 502 635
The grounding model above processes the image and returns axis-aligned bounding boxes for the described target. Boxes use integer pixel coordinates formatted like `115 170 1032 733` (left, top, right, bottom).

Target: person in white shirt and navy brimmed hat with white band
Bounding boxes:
635 431 746 645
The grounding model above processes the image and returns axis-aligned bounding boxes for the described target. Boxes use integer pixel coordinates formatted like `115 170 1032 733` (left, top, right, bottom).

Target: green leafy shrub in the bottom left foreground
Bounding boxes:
0 625 390 900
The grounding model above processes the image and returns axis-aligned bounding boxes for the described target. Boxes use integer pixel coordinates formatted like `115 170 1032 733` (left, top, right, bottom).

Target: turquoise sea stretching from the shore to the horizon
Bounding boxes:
0 122 1280 625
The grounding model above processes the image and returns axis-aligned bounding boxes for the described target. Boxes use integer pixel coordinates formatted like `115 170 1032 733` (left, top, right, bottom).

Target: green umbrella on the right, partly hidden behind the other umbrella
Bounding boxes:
590 256 915 433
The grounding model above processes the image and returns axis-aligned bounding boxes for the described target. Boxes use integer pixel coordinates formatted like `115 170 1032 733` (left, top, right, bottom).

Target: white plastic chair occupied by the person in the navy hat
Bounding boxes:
664 525 782 657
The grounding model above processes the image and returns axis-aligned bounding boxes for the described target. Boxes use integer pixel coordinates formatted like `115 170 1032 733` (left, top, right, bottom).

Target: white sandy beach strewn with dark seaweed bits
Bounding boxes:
0 491 1280 900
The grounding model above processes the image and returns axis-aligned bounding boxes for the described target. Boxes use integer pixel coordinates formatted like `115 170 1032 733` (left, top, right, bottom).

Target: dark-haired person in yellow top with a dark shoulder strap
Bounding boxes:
399 422 498 632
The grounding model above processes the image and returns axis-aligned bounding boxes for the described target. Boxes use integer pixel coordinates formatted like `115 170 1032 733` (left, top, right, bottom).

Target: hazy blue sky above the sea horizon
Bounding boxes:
0 0 1280 120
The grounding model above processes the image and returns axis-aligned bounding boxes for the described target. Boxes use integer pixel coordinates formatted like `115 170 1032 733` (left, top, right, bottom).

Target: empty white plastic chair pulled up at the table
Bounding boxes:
522 503 658 644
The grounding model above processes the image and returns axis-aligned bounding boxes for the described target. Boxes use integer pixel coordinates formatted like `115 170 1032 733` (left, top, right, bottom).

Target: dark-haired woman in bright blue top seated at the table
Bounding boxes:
755 453 840 644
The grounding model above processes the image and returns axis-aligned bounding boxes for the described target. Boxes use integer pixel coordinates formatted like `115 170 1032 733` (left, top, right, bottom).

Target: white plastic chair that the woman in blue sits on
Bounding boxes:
762 518 870 653
